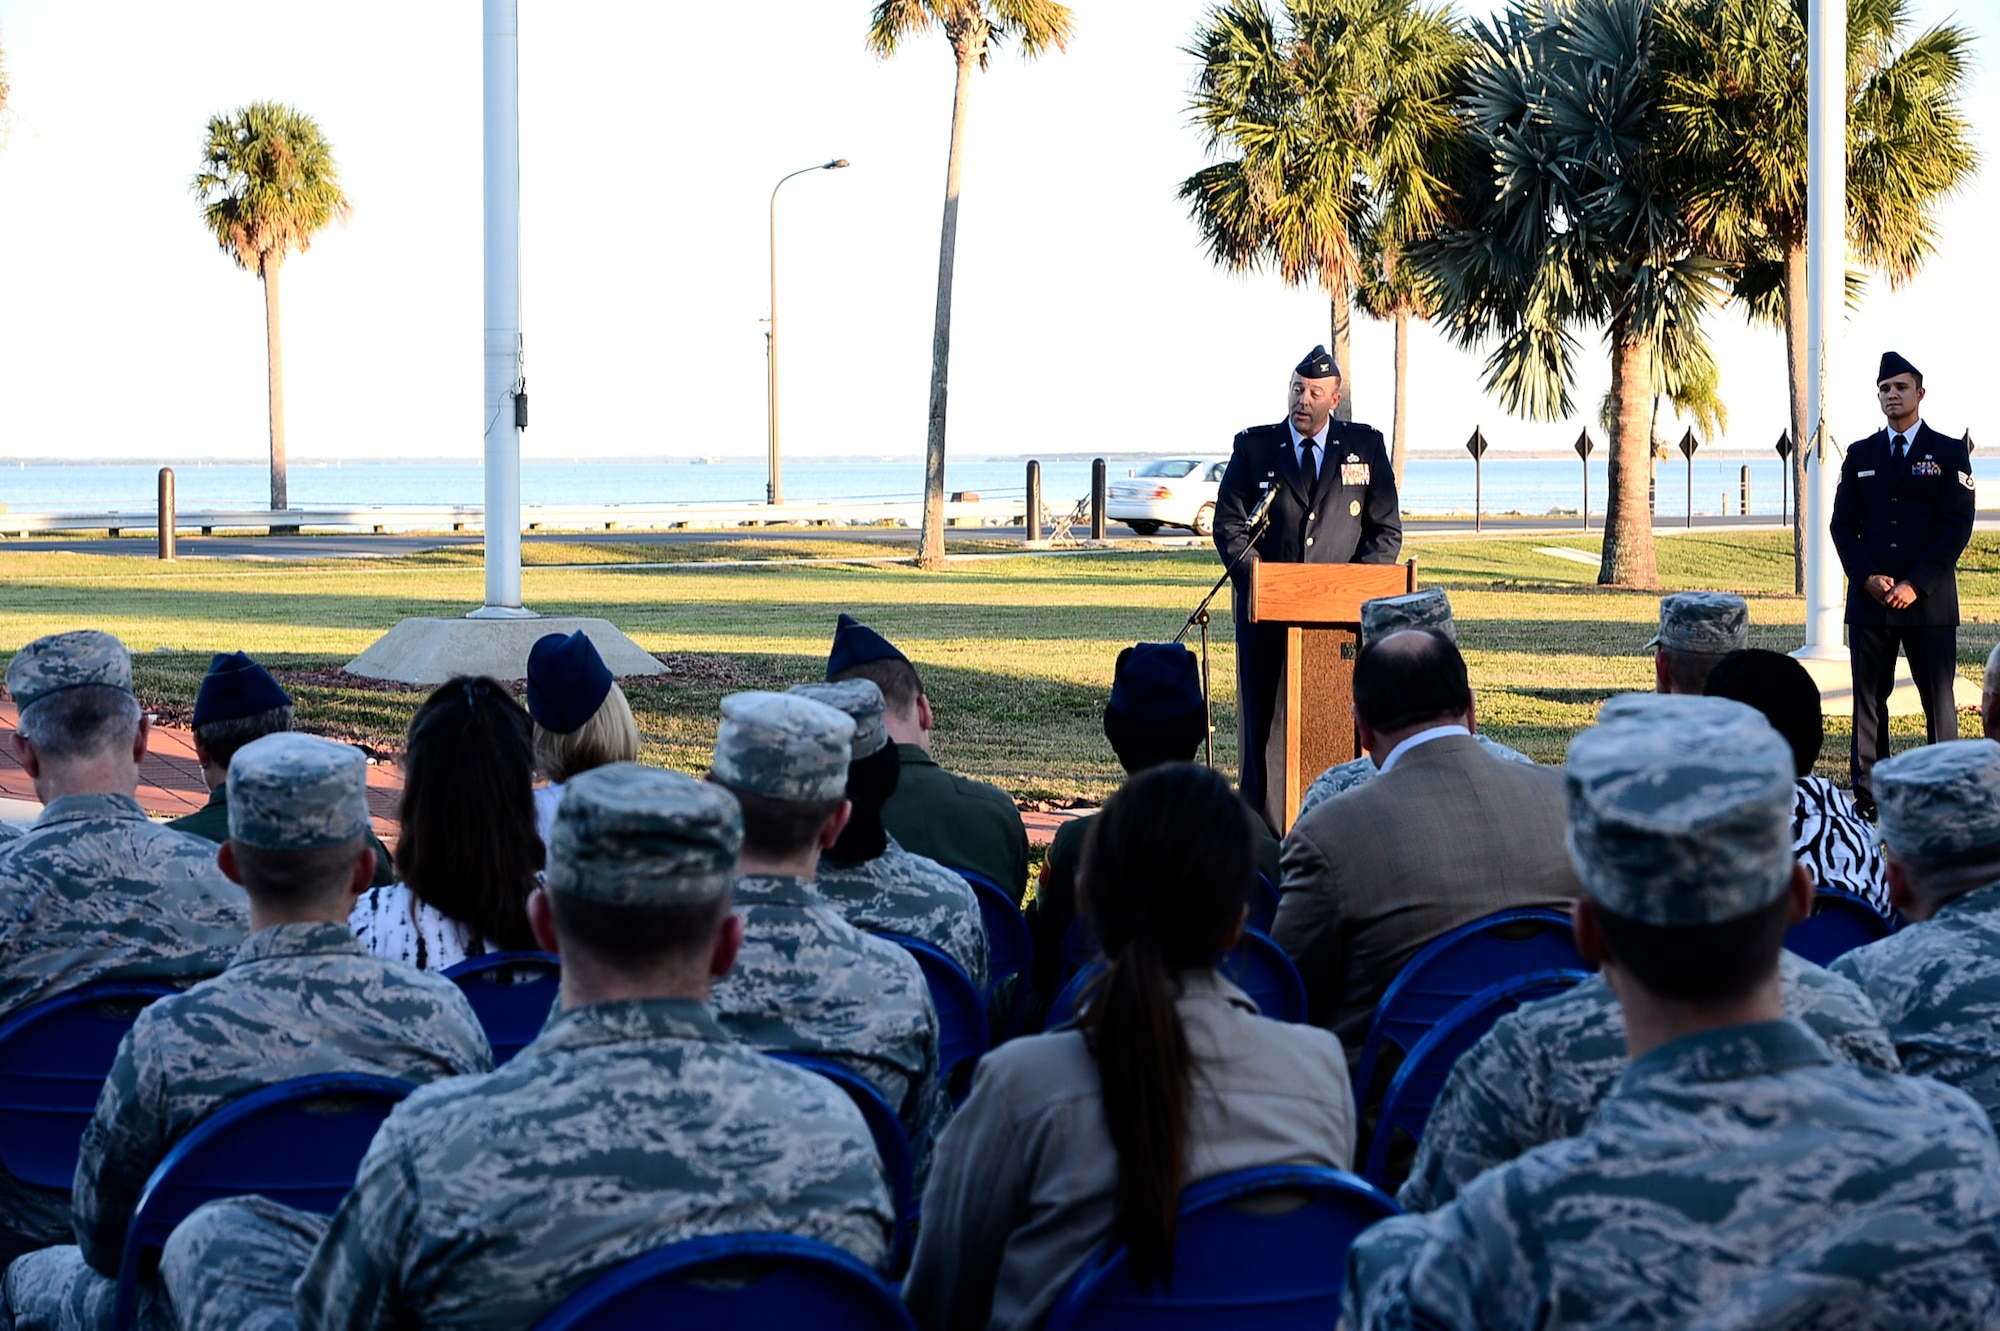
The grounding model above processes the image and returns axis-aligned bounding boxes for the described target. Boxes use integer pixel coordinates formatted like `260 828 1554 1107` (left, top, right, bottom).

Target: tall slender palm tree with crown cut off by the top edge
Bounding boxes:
868 0 1074 568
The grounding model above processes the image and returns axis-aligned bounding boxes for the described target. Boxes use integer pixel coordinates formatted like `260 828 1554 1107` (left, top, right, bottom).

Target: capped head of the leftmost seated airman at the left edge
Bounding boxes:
6 630 140 763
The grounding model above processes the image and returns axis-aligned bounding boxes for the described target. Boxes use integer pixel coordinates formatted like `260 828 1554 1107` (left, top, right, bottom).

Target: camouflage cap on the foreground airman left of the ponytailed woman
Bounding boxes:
548 763 744 905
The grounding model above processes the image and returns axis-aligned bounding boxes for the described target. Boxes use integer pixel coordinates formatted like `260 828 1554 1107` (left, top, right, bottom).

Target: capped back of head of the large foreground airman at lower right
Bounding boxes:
1564 693 1796 1001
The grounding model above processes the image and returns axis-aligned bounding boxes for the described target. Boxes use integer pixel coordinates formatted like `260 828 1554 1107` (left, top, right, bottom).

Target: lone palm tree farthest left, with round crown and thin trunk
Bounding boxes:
192 102 354 510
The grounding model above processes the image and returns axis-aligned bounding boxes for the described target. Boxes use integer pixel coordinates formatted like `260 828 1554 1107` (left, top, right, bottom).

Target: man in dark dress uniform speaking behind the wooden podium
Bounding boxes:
1214 346 1402 827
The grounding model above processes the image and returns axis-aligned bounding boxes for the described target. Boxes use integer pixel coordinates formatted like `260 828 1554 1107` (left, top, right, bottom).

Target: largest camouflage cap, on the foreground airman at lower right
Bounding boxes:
1564 693 1794 927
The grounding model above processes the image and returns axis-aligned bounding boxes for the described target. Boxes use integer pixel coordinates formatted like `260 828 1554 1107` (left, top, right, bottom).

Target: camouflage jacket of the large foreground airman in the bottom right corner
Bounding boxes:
1340 1019 2000 1331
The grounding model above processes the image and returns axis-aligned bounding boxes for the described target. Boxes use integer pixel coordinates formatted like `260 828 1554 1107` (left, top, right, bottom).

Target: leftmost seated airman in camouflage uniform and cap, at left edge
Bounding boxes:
0 630 248 1263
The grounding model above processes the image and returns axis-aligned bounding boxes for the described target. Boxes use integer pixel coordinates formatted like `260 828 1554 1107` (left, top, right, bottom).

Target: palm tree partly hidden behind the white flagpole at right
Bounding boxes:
1658 0 1976 592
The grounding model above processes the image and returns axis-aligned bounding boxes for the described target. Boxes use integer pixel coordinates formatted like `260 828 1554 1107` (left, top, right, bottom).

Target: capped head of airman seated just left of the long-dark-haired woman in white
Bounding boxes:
228 731 368 915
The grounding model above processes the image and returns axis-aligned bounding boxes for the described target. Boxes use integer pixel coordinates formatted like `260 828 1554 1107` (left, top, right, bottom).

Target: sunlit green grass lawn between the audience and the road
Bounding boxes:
0 532 2000 801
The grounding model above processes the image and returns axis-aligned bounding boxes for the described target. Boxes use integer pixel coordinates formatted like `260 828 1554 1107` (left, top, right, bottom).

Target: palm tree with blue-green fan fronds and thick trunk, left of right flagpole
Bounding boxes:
1408 0 1722 588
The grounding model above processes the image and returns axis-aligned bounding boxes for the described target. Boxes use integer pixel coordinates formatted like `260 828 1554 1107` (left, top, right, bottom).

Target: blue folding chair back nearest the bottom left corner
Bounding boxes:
112 1073 416 1331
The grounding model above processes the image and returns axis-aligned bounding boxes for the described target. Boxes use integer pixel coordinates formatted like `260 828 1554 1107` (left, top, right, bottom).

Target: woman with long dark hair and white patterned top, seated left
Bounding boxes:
348 675 544 971
